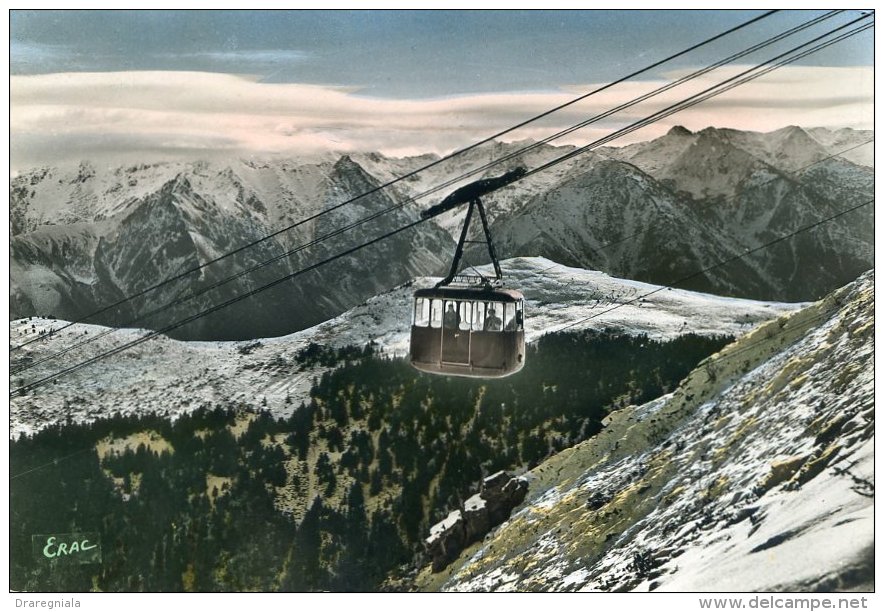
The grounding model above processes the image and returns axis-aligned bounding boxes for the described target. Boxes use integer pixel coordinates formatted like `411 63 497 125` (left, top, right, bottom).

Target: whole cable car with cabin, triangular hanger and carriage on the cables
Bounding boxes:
410 168 525 378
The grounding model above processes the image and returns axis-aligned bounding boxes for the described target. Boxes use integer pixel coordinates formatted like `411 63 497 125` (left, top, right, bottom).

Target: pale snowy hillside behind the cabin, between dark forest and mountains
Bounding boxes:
10 258 800 435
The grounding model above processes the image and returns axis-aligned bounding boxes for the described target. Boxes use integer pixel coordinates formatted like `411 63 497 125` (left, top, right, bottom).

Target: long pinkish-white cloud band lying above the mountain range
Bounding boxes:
10 66 873 170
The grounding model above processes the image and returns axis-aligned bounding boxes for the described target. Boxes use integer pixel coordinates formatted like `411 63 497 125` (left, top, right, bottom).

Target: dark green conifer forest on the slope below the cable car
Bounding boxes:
10 330 730 591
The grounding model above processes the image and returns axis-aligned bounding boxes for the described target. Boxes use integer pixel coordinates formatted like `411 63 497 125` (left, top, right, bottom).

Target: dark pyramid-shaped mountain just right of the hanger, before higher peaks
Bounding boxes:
476 160 767 294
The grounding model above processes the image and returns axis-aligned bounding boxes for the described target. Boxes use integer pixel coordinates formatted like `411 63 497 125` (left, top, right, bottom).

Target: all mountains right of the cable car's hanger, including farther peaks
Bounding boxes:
480 128 874 301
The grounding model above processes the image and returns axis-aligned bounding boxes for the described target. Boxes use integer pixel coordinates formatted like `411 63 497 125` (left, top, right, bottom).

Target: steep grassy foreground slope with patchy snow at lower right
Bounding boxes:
430 273 874 591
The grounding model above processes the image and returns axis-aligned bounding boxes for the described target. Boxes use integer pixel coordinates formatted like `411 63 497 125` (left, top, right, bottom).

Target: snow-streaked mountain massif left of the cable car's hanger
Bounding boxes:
10 156 451 339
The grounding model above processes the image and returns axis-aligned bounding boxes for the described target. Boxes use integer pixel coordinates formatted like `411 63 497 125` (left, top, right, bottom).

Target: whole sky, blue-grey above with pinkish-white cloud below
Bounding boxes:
10 10 873 171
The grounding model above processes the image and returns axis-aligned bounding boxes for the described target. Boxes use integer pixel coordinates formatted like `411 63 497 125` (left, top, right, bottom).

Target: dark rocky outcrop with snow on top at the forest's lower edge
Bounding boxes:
424 471 528 572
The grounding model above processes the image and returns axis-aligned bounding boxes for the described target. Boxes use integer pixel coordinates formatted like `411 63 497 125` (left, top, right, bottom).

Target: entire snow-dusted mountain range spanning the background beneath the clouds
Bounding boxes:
10 127 873 339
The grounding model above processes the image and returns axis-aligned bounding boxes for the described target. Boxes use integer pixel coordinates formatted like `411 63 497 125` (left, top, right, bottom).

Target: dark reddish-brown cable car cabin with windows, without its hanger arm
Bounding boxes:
411 286 525 378
